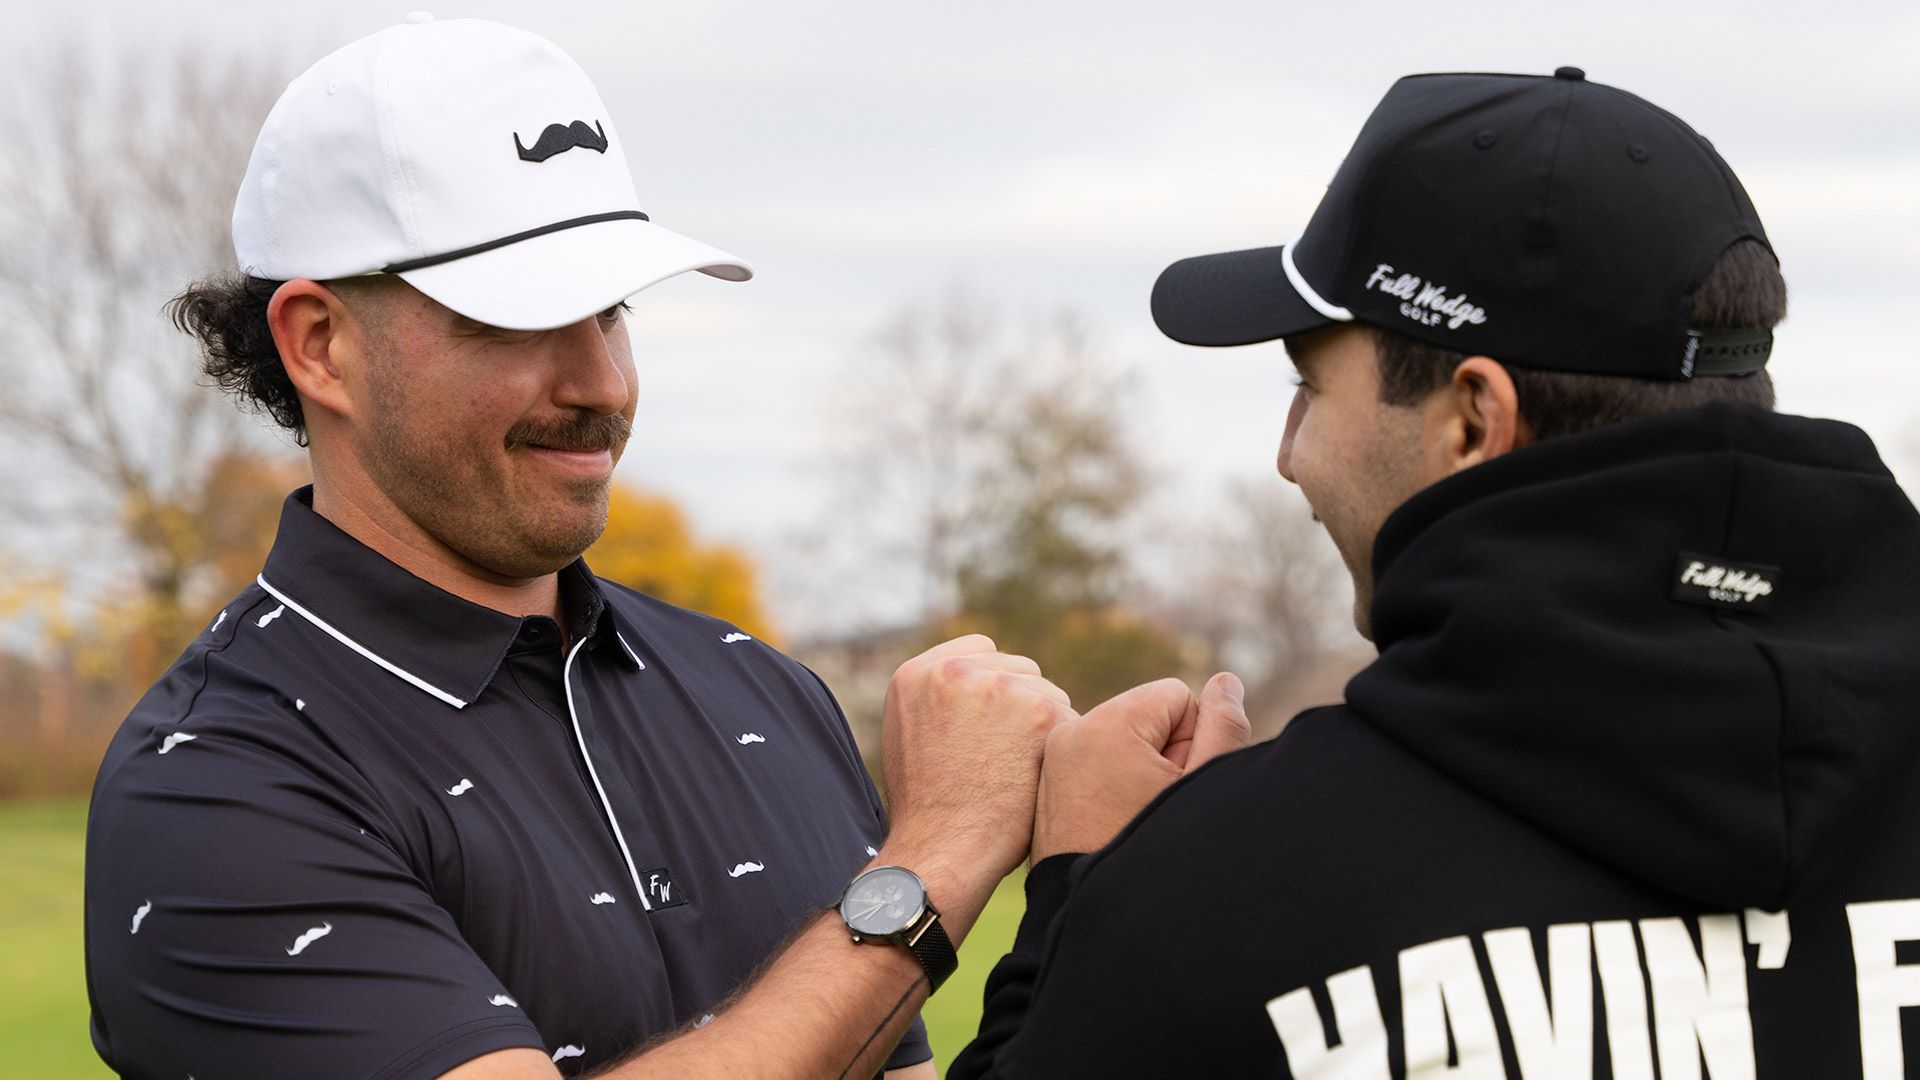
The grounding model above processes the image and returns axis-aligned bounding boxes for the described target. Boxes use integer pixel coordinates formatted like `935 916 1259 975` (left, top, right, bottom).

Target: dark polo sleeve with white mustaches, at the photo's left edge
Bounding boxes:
86 707 543 1080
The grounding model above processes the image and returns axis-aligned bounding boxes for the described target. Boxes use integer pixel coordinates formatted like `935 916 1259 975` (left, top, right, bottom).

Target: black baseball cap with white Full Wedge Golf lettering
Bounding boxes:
1152 67 1772 379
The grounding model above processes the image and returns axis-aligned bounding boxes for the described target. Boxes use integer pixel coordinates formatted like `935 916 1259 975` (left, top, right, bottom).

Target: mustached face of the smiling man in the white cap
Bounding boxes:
330 282 637 578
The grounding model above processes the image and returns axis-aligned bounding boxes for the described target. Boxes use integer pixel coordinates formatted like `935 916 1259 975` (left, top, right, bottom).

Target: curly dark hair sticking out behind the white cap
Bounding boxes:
167 273 307 446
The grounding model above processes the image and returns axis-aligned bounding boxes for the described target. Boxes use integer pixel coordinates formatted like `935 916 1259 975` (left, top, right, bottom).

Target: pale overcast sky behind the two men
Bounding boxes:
0 0 1920 626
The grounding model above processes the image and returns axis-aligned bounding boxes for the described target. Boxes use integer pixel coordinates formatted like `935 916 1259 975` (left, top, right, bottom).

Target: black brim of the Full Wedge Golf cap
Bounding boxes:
1152 246 1338 346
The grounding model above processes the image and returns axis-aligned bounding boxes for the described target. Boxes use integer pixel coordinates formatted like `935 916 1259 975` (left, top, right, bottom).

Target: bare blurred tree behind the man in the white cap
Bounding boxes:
0 42 284 630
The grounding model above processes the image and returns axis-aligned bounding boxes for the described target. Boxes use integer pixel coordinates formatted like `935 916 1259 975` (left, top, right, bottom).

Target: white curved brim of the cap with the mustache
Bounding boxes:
399 219 753 331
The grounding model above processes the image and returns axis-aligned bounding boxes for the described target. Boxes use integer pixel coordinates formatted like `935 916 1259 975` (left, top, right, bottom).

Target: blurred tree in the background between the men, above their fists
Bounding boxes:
799 288 1181 753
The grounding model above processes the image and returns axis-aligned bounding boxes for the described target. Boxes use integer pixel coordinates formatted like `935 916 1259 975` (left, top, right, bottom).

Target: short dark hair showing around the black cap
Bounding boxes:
1369 240 1788 438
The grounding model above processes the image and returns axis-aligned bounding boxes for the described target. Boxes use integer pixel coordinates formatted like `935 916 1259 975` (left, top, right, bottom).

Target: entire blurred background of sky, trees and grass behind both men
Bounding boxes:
0 0 1920 1076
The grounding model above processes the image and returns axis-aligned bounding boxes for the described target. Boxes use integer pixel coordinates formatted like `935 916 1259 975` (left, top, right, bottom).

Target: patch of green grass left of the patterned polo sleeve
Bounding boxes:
0 799 111 1078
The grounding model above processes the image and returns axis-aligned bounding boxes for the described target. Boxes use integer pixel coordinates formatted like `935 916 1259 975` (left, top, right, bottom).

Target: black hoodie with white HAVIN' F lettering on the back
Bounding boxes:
948 405 1920 1080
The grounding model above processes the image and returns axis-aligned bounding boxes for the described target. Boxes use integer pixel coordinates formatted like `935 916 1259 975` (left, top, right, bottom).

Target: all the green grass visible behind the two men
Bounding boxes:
0 799 1025 1080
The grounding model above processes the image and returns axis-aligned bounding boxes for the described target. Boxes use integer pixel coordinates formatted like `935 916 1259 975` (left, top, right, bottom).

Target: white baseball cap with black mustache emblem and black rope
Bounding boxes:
234 12 753 331
